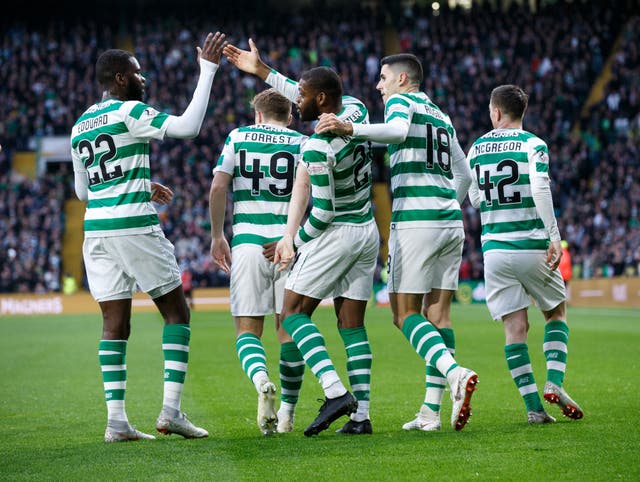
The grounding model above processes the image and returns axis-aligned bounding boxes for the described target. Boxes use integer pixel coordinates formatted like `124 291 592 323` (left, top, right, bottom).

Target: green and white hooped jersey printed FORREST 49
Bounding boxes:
213 124 307 246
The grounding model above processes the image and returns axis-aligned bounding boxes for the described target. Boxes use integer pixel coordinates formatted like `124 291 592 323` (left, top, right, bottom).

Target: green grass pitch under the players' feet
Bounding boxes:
0 305 640 481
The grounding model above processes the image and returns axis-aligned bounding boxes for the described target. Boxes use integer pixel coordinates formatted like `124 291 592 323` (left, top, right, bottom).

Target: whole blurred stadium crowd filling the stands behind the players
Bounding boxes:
0 2 640 292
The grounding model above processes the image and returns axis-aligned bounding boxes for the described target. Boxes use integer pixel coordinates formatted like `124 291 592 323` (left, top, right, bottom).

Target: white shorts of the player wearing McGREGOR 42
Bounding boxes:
484 250 566 320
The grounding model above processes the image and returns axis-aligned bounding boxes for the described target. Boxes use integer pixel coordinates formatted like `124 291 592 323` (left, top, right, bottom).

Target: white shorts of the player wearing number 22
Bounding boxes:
82 231 182 301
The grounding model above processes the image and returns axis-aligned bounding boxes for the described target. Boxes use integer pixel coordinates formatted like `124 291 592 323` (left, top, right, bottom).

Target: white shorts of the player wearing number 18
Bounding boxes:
387 228 464 294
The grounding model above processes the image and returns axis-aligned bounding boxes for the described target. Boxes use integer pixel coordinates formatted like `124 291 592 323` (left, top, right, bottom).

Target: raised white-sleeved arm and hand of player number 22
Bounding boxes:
166 32 226 139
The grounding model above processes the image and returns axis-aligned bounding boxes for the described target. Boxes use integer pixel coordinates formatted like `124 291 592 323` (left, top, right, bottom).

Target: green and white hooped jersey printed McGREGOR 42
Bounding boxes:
467 129 549 252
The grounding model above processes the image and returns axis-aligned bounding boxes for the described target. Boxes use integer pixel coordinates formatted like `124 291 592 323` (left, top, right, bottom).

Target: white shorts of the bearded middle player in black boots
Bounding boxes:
286 222 380 301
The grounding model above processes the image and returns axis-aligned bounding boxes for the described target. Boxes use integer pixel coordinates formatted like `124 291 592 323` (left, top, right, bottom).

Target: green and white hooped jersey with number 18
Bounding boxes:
385 92 466 229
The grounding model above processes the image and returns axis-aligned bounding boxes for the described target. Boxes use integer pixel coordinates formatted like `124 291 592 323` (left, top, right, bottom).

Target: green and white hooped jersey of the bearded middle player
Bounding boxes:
295 97 373 246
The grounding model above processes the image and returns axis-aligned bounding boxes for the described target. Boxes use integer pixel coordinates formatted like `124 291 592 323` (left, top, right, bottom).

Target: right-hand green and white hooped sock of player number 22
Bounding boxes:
162 324 191 410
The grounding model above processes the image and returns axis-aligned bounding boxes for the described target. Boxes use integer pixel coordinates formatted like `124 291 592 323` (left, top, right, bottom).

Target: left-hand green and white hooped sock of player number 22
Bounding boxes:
98 340 129 422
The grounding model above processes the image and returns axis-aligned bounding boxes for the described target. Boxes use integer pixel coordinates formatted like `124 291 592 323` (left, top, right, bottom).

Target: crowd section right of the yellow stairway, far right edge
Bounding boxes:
556 16 640 278
